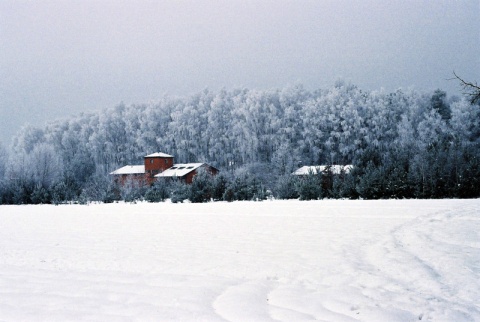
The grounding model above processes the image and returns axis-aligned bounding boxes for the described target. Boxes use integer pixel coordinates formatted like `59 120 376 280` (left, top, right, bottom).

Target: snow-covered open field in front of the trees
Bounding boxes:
0 200 480 321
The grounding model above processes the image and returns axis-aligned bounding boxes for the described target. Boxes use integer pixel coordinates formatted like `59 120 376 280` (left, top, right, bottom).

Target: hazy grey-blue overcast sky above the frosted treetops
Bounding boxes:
0 0 480 144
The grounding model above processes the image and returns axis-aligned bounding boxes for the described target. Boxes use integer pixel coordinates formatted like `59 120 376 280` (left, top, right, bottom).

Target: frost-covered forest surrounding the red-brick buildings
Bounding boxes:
0 81 480 204
